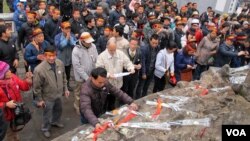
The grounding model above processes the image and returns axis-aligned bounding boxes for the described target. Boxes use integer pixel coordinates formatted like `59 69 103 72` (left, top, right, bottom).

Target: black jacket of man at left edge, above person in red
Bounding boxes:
0 39 19 73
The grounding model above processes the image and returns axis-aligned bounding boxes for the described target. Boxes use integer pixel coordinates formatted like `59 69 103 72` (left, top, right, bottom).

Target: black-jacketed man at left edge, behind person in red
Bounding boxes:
0 25 19 73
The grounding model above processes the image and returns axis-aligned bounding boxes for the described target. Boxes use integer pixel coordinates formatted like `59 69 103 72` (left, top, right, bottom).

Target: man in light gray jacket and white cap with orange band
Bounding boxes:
72 32 98 114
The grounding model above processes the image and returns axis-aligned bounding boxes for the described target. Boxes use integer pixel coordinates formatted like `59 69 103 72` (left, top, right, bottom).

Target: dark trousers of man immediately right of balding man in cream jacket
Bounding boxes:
121 73 139 98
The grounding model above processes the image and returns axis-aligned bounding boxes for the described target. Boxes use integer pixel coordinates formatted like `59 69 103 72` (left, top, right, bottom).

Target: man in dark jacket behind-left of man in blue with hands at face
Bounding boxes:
44 9 61 45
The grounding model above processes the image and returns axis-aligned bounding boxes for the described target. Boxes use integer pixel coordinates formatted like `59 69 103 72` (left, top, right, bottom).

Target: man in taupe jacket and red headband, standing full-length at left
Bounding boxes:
33 46 69 138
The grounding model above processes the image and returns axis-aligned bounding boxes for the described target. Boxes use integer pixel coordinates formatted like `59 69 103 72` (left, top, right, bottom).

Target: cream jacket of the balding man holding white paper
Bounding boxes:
96 49 134 89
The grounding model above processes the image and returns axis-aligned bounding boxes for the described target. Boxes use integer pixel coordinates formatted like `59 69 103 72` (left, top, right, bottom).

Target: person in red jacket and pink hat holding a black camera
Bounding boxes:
0 61 32 141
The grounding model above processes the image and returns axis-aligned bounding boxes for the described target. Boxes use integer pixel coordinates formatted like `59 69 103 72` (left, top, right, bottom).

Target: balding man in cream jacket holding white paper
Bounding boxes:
96 38 135 110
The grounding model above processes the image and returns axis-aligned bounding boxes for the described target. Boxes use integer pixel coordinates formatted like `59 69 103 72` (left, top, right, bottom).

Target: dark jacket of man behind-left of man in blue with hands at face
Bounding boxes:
44 18 61 45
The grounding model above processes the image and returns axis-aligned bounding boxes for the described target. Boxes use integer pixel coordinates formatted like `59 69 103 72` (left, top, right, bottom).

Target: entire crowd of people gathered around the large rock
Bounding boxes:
0 0 250 141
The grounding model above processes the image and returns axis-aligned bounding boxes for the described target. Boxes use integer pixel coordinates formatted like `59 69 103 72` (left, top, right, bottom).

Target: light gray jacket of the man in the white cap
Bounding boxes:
72 42 98 82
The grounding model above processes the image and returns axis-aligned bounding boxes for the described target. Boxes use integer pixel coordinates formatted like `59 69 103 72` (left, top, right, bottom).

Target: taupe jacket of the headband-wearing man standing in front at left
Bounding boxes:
33 59 68 101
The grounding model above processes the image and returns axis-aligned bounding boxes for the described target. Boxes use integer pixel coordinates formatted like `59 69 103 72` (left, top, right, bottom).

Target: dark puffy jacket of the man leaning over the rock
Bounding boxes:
80 79 133 126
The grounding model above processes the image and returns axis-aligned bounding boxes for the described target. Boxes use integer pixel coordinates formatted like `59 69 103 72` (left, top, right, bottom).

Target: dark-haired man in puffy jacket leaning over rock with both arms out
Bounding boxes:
80 67 138 125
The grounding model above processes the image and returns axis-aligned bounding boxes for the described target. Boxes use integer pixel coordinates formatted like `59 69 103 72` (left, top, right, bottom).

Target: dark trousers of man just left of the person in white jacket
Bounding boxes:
135 70 154 99
